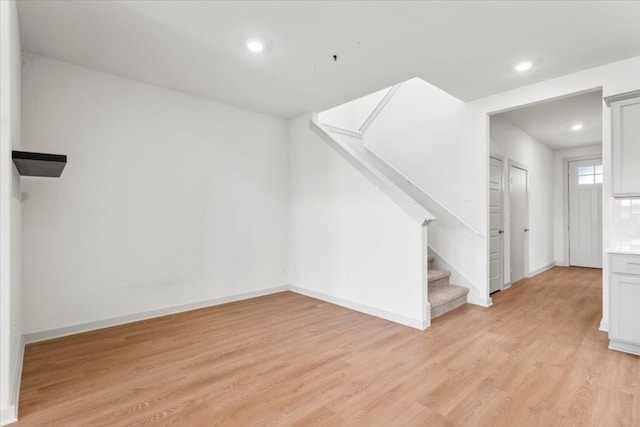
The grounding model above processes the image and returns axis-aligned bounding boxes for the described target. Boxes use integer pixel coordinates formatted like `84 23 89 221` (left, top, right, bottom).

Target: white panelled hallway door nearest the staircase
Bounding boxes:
489 157 504 292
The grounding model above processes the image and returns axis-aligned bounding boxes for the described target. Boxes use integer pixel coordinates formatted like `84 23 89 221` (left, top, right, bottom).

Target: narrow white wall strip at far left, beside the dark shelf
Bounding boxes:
0 1 22 425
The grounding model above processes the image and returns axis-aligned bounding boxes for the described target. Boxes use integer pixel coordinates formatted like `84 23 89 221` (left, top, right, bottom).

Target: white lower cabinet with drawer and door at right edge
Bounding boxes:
609 254 640 355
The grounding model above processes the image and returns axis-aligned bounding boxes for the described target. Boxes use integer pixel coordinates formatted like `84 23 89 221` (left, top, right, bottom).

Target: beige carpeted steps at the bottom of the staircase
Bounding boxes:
428 255 469 319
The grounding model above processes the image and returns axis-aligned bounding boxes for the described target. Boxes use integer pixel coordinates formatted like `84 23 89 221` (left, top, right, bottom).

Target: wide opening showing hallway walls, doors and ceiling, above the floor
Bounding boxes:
488 89 604 293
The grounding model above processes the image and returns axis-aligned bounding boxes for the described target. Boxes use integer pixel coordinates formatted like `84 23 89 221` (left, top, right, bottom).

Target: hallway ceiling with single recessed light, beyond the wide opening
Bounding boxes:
498 90 602 150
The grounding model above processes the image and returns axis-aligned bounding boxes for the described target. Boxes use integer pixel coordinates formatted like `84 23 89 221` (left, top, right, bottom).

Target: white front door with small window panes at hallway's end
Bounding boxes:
569 159 602 268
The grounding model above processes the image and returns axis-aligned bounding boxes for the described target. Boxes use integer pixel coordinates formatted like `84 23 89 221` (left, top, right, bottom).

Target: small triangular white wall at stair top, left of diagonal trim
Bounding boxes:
318 88 389 132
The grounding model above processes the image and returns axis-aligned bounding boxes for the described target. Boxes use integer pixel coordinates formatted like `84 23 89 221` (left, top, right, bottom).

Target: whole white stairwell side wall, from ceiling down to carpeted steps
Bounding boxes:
364 78 491 305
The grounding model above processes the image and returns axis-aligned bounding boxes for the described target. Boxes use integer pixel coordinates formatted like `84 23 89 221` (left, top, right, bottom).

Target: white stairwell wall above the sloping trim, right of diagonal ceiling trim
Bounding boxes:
365 78 488 234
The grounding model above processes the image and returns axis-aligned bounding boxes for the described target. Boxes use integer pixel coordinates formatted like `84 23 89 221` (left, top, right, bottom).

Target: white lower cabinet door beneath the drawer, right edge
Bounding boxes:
609 274 640 344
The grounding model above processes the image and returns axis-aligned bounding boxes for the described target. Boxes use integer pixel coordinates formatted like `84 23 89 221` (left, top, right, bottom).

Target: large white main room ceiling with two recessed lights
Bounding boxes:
18 0 640 118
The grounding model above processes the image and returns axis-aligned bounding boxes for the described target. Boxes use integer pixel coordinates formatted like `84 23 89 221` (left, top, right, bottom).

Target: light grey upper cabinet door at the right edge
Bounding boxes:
611 97 640 196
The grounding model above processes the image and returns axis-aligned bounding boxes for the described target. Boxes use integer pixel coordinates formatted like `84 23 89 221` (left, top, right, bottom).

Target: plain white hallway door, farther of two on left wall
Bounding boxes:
509 165 529 283
